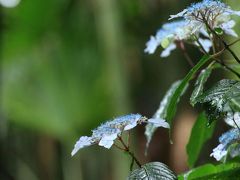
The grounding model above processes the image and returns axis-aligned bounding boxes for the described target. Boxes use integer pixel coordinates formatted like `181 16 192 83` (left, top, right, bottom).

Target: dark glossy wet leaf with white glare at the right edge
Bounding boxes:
196 79 240 123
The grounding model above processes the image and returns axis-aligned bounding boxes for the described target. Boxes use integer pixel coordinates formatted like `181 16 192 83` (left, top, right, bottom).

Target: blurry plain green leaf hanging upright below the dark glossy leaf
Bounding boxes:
187 113 215 167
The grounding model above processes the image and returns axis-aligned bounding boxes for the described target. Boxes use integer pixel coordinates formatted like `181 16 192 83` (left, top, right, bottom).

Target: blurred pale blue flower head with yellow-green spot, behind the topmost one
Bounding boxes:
144 20 212 57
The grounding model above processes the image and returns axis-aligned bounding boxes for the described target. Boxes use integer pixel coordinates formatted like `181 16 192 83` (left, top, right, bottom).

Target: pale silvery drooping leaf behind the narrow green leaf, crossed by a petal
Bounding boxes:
145 81 181 152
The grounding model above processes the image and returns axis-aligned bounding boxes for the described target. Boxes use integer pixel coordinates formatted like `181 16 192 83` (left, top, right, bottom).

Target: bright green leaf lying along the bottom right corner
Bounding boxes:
178 162 240 180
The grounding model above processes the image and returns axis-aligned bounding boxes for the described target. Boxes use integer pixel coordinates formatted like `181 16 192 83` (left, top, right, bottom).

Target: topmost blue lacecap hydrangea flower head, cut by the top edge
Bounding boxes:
170 0 240 37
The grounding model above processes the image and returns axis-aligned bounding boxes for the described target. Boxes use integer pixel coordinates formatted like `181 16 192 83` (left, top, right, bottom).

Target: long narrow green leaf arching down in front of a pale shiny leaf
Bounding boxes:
166 55 211 127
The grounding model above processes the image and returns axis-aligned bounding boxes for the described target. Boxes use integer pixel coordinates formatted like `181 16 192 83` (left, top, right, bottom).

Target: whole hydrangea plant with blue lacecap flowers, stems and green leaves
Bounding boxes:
72 0 240 179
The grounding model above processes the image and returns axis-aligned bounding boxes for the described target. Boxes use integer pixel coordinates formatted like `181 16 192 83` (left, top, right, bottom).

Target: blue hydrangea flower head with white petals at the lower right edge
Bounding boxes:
210 128 240 161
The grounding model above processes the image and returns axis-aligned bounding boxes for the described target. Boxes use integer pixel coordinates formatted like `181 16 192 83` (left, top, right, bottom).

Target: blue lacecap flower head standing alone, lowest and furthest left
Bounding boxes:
71 114 169 156
